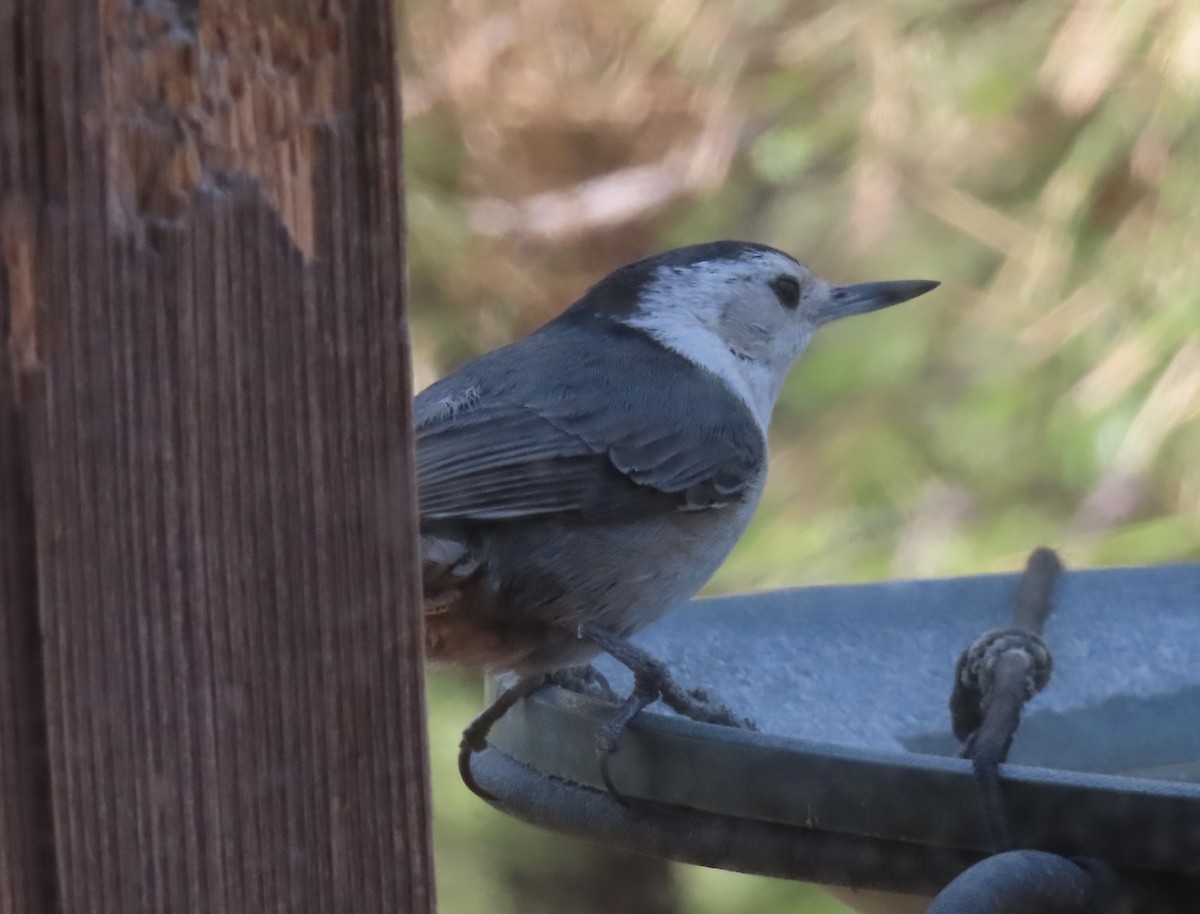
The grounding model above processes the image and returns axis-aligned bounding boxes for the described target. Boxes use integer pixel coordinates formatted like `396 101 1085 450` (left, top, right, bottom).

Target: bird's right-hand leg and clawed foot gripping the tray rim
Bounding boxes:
575 623 757 805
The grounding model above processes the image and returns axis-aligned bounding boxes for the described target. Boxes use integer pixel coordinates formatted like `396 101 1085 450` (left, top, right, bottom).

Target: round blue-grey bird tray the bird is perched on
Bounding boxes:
473 565 1200 910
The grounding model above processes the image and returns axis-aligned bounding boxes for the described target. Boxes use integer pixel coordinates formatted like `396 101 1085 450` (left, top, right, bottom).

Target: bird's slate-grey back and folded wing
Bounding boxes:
415 325 764 524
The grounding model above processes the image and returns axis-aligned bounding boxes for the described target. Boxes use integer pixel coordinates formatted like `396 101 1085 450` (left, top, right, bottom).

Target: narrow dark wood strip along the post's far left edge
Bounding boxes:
0 0 56 914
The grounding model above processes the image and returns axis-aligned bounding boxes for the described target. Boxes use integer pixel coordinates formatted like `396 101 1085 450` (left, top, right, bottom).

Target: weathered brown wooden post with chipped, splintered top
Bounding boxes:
0 0 432 914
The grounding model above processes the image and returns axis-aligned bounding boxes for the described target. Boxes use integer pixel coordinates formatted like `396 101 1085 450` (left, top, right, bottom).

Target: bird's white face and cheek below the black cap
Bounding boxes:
626 251 830 433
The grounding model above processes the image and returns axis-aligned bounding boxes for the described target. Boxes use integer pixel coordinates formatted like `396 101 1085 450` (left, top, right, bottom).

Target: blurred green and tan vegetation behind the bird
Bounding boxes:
402 0 1200 914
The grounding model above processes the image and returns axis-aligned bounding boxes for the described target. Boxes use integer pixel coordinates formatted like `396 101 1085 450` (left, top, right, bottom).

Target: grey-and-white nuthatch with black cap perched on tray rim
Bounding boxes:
414 241 938 800
